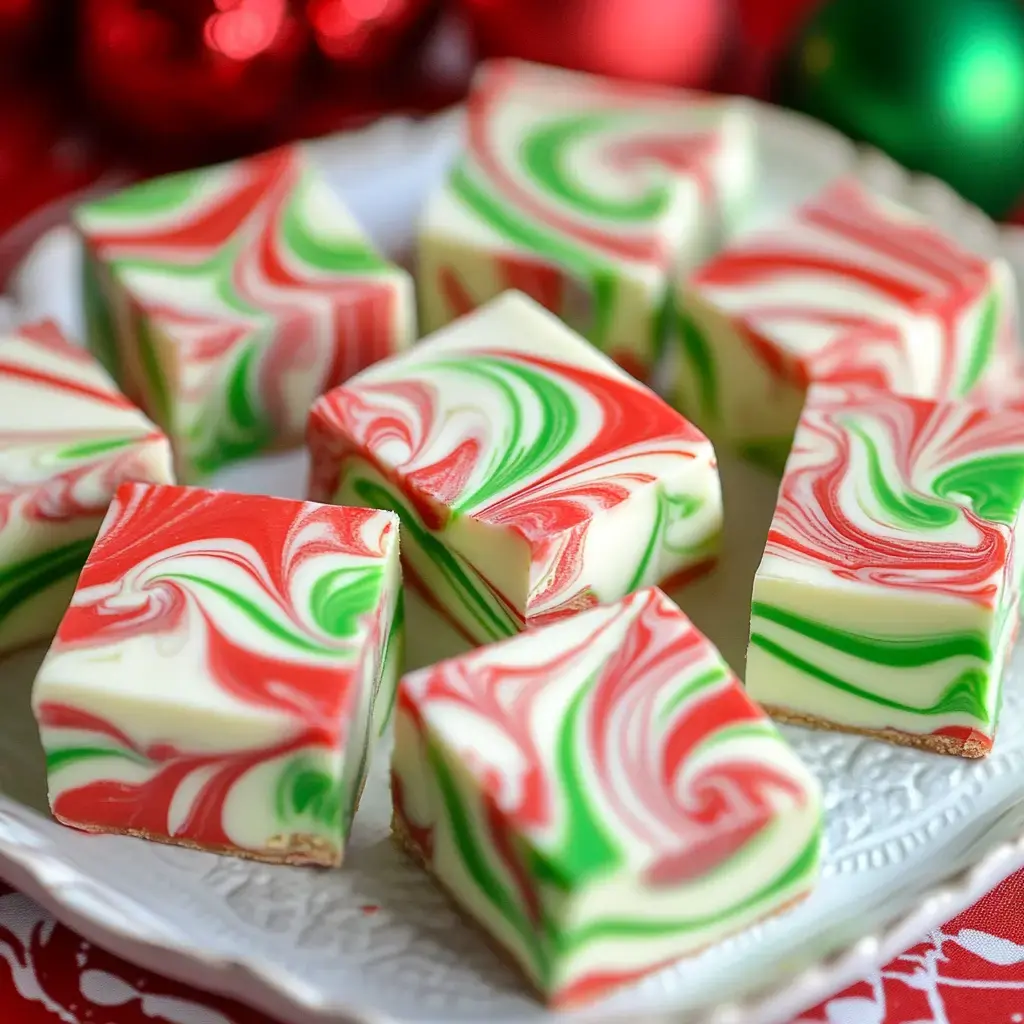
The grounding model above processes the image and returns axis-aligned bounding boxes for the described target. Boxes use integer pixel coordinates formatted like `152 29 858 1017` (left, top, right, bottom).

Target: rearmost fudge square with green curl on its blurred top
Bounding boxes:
417 59 755 378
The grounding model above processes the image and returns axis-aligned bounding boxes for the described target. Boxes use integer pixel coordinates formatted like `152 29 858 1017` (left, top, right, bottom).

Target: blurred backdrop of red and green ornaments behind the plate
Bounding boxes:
0 0 1024 289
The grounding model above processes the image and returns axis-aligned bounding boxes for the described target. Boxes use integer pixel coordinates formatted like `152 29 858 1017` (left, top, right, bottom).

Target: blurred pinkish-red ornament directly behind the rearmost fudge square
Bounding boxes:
462 0 727 87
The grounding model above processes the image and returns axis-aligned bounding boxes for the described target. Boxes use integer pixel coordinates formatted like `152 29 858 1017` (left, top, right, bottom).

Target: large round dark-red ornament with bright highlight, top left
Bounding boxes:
78 0 307 162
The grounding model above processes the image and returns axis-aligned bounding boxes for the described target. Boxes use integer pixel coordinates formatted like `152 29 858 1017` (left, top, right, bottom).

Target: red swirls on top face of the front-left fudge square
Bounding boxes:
54 483 391 735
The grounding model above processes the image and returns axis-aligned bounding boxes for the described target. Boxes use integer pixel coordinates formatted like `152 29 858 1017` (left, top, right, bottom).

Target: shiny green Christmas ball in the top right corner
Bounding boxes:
776 0 1024 217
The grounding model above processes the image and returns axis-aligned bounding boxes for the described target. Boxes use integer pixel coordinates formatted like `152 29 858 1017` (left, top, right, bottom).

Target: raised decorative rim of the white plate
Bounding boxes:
0 102 1024 1024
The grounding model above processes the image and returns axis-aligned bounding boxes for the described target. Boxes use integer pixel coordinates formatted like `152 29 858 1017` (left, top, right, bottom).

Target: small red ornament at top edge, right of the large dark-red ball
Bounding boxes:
306 0 439 73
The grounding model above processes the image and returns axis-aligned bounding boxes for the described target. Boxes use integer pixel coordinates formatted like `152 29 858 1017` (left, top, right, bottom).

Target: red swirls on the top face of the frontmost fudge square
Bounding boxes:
398 589 807 888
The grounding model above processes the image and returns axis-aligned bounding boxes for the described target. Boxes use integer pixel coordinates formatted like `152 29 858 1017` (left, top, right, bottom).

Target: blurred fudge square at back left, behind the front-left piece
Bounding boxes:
75 147 415 479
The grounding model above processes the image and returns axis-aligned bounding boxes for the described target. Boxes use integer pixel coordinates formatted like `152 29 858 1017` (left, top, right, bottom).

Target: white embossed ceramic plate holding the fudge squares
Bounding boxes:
0 106 1024 1024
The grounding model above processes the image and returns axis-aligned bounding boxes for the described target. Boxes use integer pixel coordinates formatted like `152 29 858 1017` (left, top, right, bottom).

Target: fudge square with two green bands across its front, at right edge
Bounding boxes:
746 385 1024 757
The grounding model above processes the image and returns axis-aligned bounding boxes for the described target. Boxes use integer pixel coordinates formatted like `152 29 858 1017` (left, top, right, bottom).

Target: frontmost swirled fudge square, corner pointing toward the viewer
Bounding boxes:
391 588 821 1007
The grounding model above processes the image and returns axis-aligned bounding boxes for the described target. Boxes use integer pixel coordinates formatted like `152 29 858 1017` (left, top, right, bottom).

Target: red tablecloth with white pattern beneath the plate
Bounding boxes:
6 871 1024 1024
